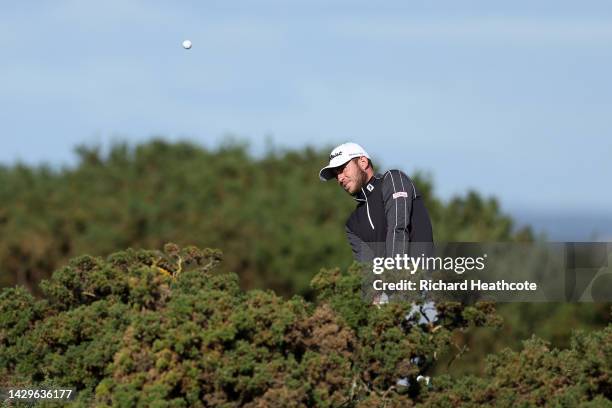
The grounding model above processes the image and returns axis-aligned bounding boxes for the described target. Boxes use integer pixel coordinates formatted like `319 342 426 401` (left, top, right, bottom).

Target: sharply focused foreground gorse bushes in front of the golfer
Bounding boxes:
0 244 612 407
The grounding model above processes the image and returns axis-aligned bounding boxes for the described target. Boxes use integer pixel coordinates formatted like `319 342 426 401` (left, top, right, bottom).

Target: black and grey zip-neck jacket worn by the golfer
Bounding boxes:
346 170 433 262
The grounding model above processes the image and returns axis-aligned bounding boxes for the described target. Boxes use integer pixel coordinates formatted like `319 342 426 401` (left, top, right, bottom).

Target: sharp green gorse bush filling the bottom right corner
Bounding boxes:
423 325 612 407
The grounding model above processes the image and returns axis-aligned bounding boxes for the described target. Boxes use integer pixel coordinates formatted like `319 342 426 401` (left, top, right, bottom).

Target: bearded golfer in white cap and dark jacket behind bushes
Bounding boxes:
319 143 433 262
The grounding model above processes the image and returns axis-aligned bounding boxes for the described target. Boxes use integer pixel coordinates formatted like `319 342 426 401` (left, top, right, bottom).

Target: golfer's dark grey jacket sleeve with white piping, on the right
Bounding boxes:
382 170 417 257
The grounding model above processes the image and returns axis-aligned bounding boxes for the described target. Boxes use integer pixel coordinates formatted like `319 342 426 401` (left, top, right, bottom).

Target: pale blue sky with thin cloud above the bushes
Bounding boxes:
0 0 612 230
